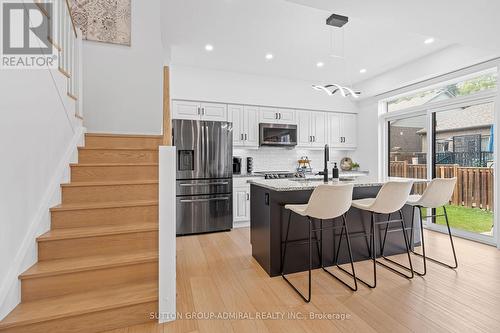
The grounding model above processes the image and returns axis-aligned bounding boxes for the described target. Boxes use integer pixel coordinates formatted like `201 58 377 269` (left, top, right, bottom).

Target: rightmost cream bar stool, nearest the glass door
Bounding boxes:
400 178 458 276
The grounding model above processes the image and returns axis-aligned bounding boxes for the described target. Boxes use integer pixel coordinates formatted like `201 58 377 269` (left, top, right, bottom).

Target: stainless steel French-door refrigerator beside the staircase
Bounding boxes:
172 120 233 235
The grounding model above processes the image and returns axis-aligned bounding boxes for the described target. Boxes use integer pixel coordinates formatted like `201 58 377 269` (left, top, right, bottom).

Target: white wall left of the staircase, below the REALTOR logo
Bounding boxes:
0 70 82 319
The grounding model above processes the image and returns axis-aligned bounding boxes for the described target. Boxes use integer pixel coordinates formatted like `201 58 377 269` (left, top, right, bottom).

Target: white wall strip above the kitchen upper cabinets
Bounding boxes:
170 64 357 112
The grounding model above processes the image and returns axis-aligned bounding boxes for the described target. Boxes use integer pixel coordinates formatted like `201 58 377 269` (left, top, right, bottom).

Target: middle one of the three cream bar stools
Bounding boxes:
352 181 414 288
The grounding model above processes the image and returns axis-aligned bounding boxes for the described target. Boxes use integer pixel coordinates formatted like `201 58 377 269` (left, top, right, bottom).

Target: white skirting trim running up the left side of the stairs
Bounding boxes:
0 127 86 320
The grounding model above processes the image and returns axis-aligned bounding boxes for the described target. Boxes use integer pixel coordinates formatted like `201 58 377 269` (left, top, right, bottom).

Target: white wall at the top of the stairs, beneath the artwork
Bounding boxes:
83 0 166 134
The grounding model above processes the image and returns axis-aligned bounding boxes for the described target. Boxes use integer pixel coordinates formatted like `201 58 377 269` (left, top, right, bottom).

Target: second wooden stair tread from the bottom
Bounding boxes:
19 251 158 280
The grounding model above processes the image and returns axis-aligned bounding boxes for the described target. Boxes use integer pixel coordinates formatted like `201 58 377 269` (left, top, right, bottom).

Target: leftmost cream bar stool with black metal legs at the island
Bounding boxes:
281 184 358 303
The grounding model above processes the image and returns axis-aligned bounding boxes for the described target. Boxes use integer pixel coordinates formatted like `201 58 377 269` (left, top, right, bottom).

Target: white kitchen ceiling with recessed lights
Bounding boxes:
162 0 500 84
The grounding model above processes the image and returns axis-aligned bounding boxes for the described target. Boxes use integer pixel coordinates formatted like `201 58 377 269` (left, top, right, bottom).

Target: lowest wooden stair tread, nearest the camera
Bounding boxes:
0 282 158 331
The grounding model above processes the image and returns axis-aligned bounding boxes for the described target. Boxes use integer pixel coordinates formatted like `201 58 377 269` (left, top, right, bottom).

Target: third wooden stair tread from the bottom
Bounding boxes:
37 222 158 242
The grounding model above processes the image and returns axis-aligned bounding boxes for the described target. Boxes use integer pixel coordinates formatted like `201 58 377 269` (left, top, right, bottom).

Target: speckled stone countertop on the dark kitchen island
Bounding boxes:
248 176 428 192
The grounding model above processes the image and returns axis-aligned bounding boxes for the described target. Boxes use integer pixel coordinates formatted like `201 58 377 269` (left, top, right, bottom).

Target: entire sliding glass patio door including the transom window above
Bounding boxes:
379 68 498 244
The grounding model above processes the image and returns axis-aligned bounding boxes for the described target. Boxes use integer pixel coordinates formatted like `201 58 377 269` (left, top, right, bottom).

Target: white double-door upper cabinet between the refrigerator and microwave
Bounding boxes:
228 105 259 148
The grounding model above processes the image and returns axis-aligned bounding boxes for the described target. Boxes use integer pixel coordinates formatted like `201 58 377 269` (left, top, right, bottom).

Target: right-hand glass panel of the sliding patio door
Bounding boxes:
431 102 496 238
